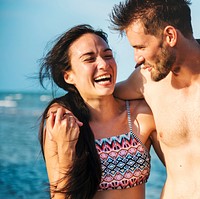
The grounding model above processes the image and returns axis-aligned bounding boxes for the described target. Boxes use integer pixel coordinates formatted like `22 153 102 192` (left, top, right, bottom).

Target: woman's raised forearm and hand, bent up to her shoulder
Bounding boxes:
44 107 79 199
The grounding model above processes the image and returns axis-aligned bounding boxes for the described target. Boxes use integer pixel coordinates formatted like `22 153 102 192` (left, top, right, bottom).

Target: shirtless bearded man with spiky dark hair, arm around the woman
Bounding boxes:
110 0 200 199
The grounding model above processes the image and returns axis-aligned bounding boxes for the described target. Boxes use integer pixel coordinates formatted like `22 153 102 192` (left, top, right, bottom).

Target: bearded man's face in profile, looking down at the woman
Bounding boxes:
125 21 176 81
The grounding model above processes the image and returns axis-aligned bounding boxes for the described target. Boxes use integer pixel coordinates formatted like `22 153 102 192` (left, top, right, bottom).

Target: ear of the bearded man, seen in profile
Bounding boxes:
163 26 177 47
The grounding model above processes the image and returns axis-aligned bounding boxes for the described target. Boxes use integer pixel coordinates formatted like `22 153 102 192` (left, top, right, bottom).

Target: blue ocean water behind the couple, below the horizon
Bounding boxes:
0 92 166 199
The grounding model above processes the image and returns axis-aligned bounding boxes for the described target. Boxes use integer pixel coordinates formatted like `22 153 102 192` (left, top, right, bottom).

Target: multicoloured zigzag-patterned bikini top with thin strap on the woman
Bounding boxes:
95 101 150 191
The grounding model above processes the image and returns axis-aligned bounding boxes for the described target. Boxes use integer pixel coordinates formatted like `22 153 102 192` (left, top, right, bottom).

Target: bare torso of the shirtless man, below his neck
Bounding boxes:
144 70 200 199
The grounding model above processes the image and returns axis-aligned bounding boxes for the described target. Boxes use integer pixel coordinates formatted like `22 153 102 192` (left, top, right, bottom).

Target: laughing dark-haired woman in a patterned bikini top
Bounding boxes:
40 25 162 199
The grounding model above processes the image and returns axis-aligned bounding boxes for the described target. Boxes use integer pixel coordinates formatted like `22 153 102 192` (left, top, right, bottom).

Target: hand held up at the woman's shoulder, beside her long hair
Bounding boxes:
46 104 82 162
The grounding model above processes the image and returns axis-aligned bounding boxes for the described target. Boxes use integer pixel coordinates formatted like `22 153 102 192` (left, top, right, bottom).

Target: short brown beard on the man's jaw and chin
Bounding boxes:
151 46 176 82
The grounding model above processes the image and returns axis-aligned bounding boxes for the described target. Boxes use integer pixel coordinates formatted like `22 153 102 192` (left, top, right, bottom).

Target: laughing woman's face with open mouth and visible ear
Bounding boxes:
64 33 117 100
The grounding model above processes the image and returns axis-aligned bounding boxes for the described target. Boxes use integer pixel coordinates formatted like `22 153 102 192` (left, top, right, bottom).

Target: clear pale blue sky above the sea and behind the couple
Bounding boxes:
0 0 200 92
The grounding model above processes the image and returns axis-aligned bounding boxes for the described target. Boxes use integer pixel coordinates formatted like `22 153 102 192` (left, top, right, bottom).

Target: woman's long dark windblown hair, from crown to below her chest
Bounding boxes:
39 24 108 199
